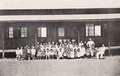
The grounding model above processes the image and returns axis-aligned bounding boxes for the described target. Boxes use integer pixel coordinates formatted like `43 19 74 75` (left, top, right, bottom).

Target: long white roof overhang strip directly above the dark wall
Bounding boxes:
0 13 120 21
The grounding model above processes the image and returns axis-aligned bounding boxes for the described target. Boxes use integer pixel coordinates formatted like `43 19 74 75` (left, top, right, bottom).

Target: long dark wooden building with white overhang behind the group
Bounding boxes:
0 8 120 49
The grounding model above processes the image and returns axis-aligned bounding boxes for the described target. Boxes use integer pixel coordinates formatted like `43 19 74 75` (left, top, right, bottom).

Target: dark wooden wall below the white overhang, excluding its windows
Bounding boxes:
0 21 120 49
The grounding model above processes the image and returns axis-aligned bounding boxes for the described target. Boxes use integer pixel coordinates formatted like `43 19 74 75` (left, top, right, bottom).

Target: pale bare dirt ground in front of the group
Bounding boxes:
0 56 120 76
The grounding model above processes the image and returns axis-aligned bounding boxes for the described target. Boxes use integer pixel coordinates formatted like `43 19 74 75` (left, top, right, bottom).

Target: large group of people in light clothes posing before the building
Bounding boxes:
16 39 105 60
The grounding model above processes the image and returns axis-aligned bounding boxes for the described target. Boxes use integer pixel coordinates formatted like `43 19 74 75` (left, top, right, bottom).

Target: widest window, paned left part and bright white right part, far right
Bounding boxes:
86 24 101 36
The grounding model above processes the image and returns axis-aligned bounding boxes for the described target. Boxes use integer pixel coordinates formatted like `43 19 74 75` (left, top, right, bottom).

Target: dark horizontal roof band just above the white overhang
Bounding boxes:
0 8 120 15
